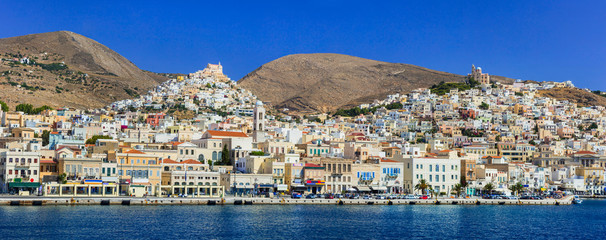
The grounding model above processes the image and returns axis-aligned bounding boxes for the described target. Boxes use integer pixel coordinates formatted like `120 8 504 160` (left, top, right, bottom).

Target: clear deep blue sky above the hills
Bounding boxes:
0 0 606 90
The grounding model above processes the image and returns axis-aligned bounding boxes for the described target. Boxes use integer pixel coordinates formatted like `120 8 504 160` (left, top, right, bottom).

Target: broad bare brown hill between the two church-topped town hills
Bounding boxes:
238 53 465 112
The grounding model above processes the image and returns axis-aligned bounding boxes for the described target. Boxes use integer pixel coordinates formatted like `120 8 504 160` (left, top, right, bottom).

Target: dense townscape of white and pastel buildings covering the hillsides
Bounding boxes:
0 64 606 200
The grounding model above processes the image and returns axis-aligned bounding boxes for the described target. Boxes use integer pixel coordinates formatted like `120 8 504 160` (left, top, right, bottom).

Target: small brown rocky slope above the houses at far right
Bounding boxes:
538 87 606 107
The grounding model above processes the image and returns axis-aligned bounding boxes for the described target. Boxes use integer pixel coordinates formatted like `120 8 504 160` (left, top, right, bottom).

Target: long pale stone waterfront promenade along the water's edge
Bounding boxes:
0 196 573 206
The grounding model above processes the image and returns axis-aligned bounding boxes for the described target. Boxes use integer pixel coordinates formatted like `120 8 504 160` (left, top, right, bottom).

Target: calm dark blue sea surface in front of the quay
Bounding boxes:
0 200 606 239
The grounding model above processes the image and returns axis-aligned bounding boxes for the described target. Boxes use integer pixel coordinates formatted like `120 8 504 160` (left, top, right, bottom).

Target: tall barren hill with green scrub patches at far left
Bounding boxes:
0 31 168 108
